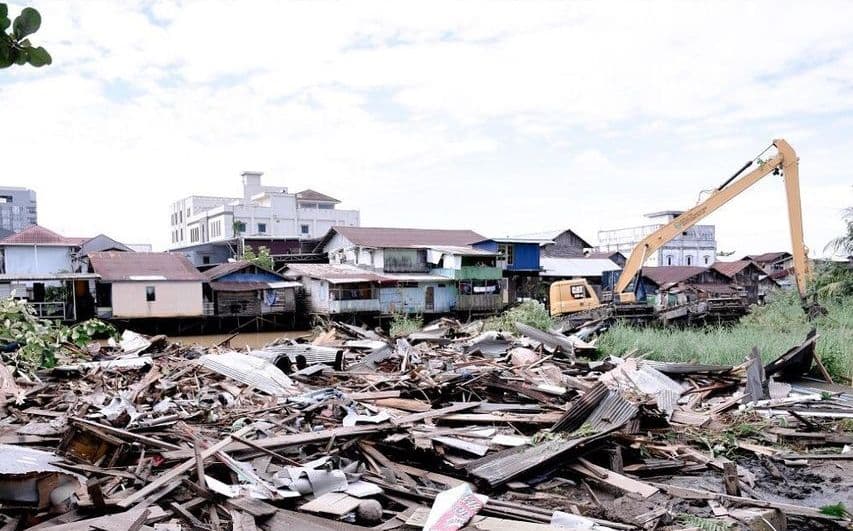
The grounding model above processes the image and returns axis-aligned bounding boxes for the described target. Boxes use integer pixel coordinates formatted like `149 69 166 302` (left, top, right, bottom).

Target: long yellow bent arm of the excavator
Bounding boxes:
613 139 810 302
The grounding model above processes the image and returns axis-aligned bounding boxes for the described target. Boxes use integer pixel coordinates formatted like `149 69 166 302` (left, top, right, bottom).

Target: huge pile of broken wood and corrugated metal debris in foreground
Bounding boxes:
0 319 853 531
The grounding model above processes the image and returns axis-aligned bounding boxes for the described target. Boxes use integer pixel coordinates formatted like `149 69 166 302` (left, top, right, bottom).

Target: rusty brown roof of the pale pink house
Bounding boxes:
89 251 207 282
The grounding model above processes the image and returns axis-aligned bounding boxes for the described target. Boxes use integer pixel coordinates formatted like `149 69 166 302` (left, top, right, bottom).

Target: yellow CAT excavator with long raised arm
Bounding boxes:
550 139 814 321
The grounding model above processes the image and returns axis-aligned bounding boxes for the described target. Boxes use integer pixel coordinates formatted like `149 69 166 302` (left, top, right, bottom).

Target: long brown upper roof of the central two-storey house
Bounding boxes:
322 227 487 247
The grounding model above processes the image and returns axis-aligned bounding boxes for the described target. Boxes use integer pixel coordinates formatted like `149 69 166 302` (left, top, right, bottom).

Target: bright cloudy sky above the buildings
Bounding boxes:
0 0 853 256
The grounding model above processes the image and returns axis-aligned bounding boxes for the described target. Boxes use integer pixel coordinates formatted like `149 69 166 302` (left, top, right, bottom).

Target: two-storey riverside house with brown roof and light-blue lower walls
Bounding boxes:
286 227 505 315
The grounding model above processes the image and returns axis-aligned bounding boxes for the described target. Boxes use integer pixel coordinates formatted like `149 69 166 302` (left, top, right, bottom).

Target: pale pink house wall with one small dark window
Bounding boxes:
112 281 203 319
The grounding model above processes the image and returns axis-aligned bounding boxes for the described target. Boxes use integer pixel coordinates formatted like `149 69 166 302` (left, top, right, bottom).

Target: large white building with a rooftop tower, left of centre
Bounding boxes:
169 171 360 249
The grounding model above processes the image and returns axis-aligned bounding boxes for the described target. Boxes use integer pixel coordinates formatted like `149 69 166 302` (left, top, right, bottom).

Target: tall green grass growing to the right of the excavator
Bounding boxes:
598 293 853 381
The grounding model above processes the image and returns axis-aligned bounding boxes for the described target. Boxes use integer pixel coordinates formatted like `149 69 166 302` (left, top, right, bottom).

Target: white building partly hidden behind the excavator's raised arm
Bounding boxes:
597 210 717 266
